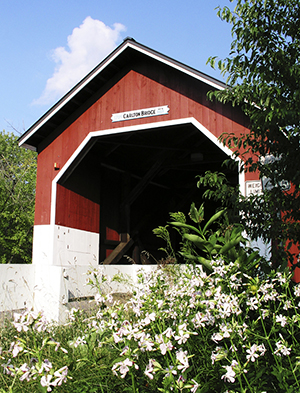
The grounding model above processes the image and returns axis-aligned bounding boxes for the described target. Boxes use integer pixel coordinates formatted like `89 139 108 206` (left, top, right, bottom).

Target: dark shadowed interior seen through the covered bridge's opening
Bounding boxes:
60 124 238 263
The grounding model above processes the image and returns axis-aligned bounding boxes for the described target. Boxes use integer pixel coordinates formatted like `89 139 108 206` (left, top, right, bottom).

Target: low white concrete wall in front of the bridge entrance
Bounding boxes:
0 265 157 323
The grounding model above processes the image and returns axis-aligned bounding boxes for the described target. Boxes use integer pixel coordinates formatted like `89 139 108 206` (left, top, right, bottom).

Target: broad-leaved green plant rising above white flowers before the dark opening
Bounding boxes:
154 198 269 275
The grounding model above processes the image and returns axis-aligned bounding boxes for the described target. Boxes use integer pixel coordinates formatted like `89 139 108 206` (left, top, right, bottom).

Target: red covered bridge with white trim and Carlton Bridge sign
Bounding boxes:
20 38 260 266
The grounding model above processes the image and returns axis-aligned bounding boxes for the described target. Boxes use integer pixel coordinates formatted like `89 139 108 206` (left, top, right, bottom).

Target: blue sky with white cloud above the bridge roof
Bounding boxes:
0 0 232 133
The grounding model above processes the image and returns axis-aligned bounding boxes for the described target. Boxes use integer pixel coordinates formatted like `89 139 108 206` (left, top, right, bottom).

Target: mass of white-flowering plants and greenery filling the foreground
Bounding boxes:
0 260 300 393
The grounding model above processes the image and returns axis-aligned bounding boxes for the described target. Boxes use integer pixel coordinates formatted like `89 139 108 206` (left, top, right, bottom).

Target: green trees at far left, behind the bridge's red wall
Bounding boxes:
0 132 36 263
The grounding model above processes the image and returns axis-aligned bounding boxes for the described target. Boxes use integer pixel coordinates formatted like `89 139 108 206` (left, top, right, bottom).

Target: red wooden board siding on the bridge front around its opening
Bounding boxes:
35 65 251 225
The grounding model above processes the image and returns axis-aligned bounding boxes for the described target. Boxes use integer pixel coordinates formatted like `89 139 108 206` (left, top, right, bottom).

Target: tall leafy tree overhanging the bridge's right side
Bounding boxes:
209 0 300 265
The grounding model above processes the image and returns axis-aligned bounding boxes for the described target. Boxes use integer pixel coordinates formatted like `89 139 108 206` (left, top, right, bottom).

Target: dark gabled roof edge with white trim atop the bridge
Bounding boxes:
19 37 226 150
